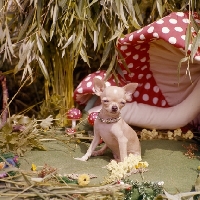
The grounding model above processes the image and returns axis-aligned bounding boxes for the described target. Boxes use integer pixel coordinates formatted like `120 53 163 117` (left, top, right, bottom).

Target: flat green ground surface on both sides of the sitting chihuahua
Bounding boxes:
20 140 200 194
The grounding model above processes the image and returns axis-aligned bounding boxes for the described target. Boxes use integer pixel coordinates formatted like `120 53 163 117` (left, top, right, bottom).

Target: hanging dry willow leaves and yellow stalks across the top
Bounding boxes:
0 0 200 114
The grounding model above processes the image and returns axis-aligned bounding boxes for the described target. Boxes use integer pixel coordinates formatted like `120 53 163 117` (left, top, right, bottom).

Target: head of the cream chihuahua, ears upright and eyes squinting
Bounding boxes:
93 78 138 116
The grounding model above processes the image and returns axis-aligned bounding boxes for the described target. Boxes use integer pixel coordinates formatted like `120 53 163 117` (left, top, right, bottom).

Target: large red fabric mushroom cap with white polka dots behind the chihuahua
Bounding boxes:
74 12 200 107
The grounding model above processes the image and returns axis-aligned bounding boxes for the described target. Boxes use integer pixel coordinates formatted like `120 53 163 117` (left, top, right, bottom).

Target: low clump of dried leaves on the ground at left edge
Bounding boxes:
0 115 47 156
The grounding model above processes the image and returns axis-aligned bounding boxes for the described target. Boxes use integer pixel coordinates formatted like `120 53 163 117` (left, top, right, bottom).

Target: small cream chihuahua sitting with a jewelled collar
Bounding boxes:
76 78 141 162
